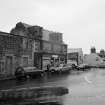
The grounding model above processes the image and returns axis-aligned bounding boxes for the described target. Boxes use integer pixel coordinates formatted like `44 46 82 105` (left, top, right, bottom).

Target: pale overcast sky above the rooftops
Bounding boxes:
0 0 105 53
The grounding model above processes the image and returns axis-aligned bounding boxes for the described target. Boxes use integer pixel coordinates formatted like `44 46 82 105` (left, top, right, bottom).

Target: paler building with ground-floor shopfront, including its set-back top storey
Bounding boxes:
42 29 67 67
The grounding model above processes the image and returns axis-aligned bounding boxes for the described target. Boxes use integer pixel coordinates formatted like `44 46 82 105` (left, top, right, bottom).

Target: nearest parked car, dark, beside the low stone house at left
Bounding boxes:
15 67 44 79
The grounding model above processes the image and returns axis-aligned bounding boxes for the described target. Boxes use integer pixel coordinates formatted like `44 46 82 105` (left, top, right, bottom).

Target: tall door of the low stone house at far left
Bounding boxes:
6 56 13 75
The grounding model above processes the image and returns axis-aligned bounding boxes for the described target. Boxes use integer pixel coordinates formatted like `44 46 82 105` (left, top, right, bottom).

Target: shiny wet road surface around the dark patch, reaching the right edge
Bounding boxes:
0 69 105 105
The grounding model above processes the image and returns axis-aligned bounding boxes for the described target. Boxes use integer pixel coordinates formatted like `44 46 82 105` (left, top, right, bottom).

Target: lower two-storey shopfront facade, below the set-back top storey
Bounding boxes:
42 41 67 68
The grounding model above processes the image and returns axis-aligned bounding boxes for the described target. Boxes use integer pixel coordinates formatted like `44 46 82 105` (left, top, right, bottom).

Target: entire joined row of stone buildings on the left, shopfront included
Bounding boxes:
0 22 67 76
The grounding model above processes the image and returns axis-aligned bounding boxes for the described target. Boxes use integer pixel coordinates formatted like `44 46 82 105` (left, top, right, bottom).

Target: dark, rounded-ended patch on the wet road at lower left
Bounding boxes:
0 87 69 105
